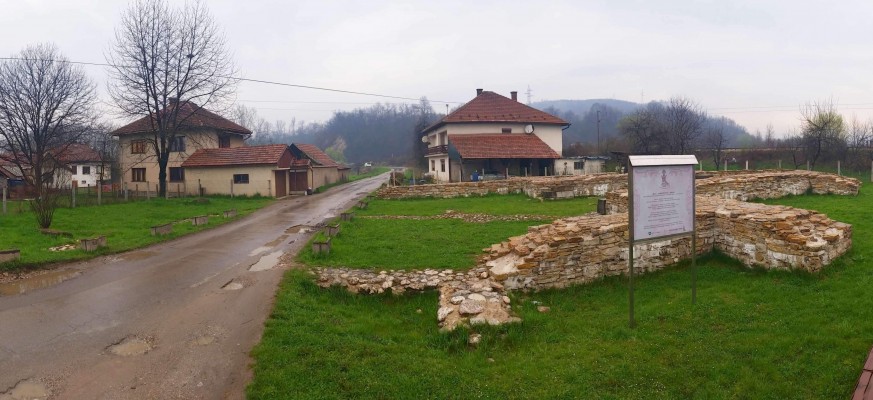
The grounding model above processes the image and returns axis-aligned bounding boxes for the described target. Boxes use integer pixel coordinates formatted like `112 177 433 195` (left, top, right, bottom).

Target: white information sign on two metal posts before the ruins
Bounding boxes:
628 155 698 328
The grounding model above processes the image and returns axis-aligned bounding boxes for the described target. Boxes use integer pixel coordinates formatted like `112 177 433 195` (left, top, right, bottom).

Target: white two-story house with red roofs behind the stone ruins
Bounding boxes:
421 89 570 182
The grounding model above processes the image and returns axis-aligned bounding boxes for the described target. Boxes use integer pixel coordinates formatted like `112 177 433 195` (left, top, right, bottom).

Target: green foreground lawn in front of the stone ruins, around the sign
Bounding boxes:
248 184 873 399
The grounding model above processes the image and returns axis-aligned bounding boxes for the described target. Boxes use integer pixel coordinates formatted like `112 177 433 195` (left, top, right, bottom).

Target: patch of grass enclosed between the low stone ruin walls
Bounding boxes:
298 195 597 270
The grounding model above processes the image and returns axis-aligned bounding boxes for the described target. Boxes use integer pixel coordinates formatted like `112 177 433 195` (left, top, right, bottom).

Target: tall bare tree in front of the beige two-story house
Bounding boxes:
106 0 237 196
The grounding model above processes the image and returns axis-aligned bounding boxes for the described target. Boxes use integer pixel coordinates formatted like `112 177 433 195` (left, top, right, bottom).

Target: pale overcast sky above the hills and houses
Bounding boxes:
0 0 873 133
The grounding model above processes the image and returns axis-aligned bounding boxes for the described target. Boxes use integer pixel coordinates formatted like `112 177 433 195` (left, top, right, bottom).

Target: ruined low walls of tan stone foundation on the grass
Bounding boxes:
315 170 860 329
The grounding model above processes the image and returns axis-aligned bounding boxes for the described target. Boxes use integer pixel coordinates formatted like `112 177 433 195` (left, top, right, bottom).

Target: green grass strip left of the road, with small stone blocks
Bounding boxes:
0 196 272 270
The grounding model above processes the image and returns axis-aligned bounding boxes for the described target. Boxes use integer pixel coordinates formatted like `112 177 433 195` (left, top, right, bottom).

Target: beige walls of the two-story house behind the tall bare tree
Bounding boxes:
119 129 245 190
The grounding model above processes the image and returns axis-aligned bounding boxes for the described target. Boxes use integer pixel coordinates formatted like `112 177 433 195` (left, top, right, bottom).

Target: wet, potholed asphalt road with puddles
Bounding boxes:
0 174 387 399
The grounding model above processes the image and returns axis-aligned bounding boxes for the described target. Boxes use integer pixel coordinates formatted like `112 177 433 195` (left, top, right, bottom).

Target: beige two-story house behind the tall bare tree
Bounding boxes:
112 101 252 193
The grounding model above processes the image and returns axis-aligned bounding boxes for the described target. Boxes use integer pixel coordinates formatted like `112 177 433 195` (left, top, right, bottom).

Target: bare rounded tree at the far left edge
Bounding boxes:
0 44 95 228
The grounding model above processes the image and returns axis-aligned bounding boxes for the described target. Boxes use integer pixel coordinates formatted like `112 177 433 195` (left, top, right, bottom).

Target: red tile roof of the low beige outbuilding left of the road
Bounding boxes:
182 144 288 168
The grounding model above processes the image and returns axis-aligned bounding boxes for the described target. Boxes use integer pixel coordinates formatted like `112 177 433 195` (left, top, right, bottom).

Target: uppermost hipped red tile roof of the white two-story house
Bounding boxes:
423 91 570 132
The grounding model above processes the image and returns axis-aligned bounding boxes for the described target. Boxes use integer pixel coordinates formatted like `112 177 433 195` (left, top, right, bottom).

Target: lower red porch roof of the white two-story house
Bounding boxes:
449 134 561 159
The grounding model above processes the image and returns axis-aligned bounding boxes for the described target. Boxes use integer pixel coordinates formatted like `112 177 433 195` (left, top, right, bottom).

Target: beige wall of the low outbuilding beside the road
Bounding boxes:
185 165 276 196
